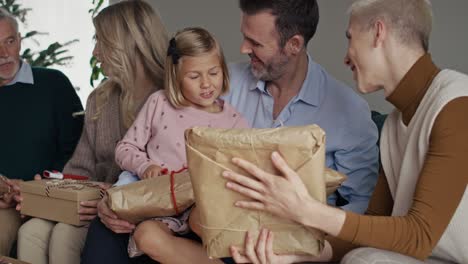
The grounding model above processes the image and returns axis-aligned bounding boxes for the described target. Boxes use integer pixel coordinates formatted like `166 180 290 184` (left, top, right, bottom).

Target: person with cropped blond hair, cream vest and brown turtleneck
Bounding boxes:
225 0 468 264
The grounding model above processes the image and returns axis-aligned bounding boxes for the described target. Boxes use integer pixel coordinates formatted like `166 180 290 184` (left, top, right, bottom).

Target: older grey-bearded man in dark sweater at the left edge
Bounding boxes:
0 9 83 255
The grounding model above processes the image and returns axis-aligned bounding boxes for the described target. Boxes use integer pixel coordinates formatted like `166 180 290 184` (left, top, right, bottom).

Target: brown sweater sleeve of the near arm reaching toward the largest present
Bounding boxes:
338 97 468 259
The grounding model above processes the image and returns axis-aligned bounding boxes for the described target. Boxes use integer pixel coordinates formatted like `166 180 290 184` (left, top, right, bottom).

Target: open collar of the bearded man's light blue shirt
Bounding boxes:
250 54 320 106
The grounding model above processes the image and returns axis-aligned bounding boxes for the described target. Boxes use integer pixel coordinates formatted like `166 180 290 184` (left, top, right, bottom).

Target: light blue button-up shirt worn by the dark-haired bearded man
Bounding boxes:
225 56 378 213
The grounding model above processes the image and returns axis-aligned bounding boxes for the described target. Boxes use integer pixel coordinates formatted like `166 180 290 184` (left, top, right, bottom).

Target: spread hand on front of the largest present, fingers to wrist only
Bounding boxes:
223 152 319 223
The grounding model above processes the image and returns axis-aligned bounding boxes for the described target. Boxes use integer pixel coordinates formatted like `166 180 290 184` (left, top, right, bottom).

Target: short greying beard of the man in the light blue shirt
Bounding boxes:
249 52 289 81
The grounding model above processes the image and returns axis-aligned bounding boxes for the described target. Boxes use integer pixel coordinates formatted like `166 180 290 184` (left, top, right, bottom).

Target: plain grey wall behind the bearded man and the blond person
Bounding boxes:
135 0 468 112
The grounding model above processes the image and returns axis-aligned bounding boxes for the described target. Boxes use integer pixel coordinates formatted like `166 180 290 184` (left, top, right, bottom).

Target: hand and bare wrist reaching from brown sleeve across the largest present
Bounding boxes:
223 152 346 239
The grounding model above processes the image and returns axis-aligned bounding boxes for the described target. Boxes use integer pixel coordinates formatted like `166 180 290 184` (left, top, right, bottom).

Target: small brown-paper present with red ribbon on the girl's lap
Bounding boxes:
107 169 194 223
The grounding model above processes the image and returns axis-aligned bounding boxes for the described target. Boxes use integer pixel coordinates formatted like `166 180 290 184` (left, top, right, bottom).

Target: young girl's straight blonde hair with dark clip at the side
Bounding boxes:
164 27 229 108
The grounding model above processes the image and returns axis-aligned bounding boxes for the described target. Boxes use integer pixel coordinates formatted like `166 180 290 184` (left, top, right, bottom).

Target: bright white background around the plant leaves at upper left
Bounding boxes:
18 0 108 106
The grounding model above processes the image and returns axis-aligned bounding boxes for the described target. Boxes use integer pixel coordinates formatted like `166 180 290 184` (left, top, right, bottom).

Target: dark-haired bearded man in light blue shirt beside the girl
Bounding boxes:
226 0 378 213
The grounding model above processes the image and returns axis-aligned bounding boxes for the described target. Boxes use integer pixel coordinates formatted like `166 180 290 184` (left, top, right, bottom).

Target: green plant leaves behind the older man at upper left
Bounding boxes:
0 0 78 67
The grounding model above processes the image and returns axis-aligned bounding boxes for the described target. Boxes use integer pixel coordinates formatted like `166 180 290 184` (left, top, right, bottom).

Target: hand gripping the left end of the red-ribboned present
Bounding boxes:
97 196 135 234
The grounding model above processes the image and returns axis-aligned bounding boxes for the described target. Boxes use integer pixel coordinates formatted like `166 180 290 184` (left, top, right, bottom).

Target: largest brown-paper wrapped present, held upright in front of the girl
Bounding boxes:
185 125 326 258
